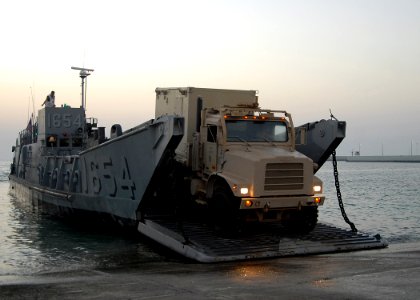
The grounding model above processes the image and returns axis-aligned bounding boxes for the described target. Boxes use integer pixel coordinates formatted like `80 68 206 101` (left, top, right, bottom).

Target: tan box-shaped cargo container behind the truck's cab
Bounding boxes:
155 87 258 163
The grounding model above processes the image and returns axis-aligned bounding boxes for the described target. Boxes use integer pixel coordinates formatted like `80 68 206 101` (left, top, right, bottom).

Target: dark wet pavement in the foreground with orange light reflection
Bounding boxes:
0 243 420 300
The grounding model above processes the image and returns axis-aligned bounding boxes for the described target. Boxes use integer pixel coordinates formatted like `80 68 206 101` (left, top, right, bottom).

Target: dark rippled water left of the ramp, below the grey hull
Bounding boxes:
0 178 177 275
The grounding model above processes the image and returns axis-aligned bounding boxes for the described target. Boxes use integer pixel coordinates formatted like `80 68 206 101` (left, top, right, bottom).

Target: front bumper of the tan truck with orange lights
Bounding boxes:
239 195 325 210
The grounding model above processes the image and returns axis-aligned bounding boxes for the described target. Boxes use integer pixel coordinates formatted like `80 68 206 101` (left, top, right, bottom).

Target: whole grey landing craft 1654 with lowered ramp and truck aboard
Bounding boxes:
9 67 386 262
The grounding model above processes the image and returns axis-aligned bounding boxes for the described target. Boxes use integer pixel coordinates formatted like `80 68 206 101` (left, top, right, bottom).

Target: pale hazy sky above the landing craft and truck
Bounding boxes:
0 0 420 161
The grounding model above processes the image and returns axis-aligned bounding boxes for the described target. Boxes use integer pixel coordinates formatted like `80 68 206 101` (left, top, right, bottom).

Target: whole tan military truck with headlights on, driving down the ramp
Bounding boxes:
156 87 325 232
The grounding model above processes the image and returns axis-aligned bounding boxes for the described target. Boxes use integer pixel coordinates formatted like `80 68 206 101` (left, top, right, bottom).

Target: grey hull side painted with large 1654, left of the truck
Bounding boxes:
9 113 183 225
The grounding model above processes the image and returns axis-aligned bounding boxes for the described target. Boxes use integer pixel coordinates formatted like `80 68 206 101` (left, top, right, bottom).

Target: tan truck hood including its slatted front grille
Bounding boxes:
219 144 313 197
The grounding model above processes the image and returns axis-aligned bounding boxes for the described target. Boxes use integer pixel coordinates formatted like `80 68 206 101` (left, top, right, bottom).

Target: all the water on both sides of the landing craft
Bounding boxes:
0 162 420 279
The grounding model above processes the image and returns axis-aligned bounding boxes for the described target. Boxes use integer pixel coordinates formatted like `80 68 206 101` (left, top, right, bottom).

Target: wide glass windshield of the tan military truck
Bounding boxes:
226 120 287 142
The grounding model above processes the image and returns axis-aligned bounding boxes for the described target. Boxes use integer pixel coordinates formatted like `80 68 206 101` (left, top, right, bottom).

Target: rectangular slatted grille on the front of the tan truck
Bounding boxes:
264 163 303 191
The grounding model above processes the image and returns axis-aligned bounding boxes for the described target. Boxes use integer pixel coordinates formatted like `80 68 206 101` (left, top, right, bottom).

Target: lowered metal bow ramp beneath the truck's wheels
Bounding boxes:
138 218 388 263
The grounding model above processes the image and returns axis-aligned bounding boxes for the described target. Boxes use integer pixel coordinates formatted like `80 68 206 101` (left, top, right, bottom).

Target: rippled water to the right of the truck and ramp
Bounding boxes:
317 162 420 243
